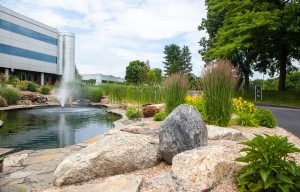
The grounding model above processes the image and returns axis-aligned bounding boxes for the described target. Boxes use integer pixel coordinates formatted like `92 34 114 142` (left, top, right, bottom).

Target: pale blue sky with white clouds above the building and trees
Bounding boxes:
0 0 206 77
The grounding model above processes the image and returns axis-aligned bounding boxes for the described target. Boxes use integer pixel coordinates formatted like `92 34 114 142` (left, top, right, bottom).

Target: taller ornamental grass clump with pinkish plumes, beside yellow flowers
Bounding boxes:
202 60 235 127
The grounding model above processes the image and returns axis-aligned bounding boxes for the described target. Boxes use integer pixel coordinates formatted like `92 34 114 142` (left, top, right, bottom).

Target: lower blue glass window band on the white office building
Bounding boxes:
0 44 57 64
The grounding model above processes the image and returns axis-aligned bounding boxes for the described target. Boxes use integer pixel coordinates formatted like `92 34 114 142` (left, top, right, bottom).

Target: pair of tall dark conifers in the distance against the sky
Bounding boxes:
163 44 192 76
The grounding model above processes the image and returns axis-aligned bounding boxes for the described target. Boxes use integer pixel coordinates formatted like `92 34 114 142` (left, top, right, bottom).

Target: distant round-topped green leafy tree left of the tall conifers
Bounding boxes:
125 60 148 84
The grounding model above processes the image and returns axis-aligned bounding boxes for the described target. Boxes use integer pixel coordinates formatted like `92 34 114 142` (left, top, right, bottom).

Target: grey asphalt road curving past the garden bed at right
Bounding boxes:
258 106 300 138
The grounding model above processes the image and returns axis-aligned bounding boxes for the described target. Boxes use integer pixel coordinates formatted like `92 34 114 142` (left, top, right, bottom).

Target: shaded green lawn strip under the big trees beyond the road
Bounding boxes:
235 90 300 107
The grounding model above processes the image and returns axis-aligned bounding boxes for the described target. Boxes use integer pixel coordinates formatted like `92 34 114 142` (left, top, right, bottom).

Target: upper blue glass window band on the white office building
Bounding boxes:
0 19 57 46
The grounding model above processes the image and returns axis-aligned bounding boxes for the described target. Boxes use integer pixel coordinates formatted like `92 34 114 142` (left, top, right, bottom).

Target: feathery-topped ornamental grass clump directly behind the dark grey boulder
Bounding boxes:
162 73 188 113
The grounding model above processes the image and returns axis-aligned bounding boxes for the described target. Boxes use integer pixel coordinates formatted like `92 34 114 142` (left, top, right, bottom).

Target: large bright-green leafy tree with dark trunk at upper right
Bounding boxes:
200 0 300 91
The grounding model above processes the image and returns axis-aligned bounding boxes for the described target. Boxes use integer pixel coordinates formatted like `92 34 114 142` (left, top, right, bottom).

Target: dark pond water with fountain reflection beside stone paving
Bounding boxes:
0 107 119 150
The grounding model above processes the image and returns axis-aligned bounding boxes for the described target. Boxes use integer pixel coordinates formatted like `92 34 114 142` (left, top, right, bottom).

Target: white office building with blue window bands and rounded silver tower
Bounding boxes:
0 6 75 85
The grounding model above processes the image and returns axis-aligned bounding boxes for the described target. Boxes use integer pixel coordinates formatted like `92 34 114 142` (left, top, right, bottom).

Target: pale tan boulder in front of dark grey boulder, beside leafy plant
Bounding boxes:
170 146 240 191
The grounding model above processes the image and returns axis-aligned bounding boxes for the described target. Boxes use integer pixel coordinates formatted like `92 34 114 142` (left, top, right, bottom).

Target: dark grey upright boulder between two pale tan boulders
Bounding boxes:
158 104 207 164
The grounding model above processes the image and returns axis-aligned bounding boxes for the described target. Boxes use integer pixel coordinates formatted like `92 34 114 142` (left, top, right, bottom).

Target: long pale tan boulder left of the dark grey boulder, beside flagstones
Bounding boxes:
53 130 161 186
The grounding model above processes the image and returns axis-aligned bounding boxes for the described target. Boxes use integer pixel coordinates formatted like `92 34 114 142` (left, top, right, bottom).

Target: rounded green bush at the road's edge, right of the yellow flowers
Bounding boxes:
254 109 277 128
